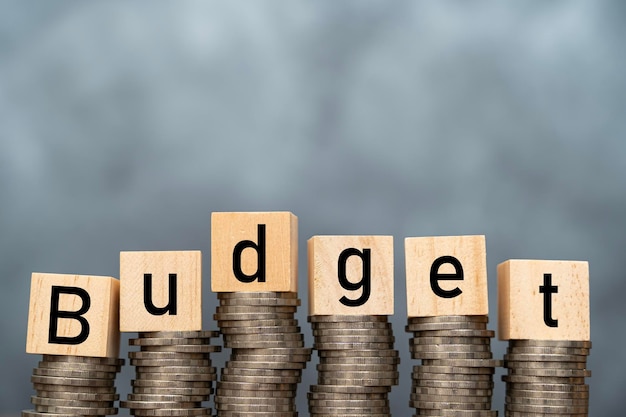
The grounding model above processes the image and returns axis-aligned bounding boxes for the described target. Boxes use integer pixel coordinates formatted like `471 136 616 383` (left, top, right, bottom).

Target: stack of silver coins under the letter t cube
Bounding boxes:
502 340 591 417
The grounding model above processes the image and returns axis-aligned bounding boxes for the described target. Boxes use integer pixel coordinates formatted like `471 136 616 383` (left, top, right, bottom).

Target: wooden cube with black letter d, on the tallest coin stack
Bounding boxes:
211 212 298 292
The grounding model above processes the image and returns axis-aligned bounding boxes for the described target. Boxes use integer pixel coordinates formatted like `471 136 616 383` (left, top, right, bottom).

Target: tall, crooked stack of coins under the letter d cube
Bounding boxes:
214 292 311 417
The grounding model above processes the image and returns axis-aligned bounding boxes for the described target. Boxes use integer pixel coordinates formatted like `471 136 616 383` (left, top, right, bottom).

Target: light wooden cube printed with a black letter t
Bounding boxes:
498 259 590 340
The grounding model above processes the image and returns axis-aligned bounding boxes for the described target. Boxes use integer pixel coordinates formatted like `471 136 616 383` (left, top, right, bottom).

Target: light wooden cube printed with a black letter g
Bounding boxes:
308 236 393 315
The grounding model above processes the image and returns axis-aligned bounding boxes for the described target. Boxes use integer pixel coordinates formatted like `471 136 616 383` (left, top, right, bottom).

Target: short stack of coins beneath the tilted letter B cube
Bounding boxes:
22 355 124 417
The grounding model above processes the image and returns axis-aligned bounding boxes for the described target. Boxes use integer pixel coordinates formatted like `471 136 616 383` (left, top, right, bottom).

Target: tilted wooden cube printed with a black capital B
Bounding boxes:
26 273 120 357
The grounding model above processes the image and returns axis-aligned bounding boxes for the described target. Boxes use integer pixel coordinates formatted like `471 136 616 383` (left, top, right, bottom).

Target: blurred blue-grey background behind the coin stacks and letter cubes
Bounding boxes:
0 0 626 416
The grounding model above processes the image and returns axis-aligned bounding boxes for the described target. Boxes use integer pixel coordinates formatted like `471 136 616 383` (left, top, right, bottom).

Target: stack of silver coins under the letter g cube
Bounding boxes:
308 315 400 417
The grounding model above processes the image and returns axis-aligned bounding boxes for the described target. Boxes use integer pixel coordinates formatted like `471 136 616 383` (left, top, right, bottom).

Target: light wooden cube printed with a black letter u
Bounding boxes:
120 251 202 332
